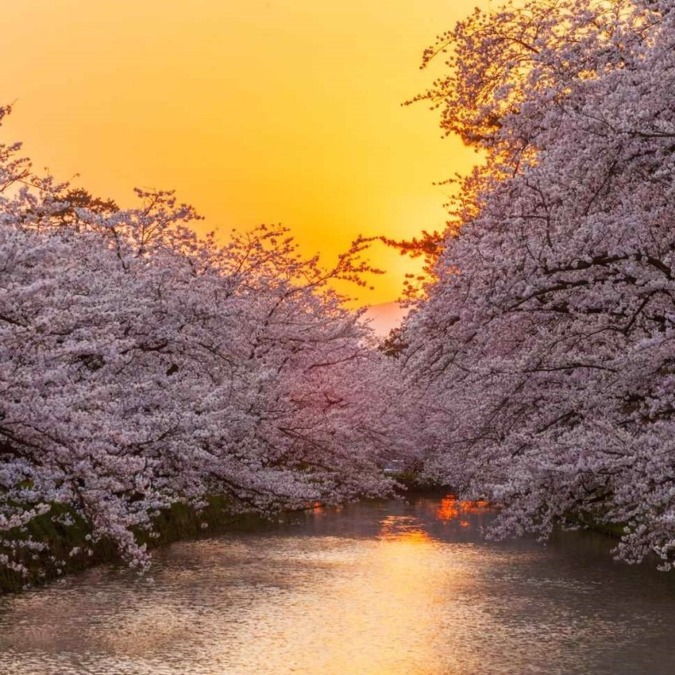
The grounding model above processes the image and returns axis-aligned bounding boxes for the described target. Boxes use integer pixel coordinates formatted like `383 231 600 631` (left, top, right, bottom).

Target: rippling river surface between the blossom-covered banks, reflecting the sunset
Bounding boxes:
0 497 675 675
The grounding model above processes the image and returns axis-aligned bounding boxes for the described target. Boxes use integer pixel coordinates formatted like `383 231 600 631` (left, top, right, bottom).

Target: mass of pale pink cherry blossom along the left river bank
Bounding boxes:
0 109 402 570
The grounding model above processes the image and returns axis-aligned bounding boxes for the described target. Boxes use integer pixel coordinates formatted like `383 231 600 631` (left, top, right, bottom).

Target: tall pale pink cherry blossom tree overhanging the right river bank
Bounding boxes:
403 0 675 569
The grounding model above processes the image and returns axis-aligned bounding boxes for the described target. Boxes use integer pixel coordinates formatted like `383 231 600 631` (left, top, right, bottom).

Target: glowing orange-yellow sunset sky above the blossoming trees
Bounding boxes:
0 0 488 304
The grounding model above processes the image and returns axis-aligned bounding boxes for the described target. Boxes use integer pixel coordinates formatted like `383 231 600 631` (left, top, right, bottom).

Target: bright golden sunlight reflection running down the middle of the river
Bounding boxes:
215 515 460 675
